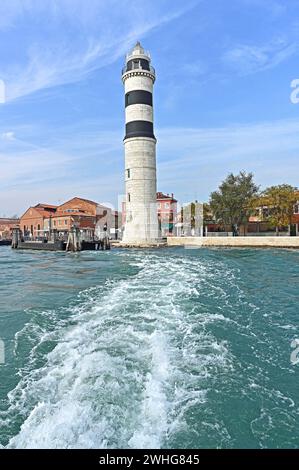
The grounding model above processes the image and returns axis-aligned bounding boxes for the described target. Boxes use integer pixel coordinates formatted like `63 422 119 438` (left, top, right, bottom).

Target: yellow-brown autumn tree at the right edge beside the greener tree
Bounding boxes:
255 184 298 235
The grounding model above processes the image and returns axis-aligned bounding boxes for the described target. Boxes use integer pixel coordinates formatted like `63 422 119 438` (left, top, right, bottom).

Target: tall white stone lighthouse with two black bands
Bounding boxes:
122 42 158 246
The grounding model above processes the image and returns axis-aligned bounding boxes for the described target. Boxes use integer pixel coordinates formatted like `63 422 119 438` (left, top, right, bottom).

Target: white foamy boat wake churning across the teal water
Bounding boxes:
3 252 236 448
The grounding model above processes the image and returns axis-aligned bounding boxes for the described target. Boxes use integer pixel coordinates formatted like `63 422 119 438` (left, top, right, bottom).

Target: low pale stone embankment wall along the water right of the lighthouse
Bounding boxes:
167 236 299 248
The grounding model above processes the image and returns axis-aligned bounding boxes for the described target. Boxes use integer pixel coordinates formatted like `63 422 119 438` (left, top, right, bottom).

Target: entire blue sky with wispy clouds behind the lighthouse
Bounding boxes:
0 0 299 216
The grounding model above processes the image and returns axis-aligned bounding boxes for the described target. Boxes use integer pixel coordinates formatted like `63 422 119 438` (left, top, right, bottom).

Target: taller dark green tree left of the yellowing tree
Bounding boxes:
209 171 259 232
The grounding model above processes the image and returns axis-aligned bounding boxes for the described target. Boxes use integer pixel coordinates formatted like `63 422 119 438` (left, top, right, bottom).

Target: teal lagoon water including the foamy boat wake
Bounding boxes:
0 247 299 448
